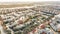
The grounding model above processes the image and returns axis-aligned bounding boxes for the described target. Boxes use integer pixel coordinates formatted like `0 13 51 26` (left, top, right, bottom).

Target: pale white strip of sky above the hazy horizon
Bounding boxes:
0 0 60 2
